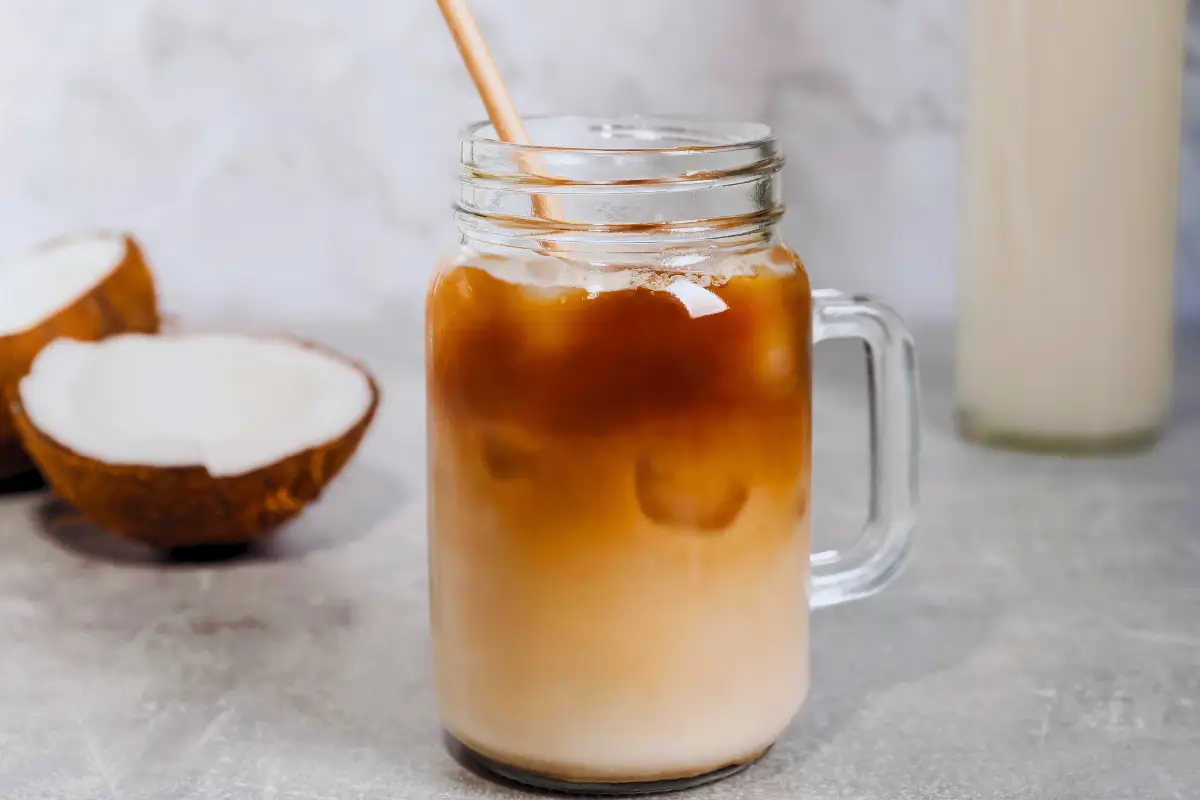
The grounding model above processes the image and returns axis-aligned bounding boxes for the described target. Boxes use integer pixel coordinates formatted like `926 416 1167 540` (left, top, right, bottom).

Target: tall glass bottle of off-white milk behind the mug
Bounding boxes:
958 0 1187 452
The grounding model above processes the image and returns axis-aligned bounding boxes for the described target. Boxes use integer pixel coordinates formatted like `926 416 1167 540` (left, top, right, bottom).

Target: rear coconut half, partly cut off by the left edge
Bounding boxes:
0 231 158 479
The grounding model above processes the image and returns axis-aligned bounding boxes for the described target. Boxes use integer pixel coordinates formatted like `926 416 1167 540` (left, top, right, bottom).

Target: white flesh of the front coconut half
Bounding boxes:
19 333 372 477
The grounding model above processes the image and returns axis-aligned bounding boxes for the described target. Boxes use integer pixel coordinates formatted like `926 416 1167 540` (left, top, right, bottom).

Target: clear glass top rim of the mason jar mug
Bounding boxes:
460 114 775 156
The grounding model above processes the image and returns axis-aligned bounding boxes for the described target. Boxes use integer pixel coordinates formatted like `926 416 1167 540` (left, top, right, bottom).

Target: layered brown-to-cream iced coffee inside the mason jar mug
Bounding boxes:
427 247 811 783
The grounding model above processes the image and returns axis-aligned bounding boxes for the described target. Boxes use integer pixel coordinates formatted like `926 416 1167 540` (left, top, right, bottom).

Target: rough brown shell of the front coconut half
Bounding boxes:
8 345 379 548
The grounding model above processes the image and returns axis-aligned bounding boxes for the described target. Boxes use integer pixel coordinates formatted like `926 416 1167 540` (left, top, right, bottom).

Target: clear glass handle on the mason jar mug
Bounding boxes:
810 290 920 608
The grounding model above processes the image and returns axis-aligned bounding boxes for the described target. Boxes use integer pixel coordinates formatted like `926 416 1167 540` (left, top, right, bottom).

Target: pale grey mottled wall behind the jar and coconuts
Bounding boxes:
0 0 1200 323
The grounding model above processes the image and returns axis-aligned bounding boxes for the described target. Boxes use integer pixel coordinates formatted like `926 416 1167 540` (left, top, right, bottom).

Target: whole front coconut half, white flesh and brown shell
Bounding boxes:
12 333 379 547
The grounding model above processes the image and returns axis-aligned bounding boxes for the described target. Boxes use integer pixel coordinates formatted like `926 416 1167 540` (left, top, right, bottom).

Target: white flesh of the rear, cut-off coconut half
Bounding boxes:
0 233 128 336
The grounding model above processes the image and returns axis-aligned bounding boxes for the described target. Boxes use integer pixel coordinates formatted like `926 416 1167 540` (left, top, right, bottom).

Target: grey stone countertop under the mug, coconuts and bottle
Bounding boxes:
0 326 1200 800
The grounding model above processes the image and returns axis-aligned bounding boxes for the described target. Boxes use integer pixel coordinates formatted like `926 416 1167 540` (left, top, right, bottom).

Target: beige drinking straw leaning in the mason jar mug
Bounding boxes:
438 0 563 219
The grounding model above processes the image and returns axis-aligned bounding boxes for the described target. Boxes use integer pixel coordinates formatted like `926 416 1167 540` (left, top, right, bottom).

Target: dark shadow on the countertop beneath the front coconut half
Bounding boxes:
36 461 409 567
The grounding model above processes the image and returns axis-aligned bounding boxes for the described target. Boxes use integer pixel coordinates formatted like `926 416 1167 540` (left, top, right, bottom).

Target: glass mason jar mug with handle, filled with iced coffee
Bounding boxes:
426 118 917 793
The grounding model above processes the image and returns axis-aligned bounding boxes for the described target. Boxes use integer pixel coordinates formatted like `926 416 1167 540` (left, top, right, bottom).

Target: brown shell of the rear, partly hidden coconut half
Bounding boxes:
0 234 158 479
